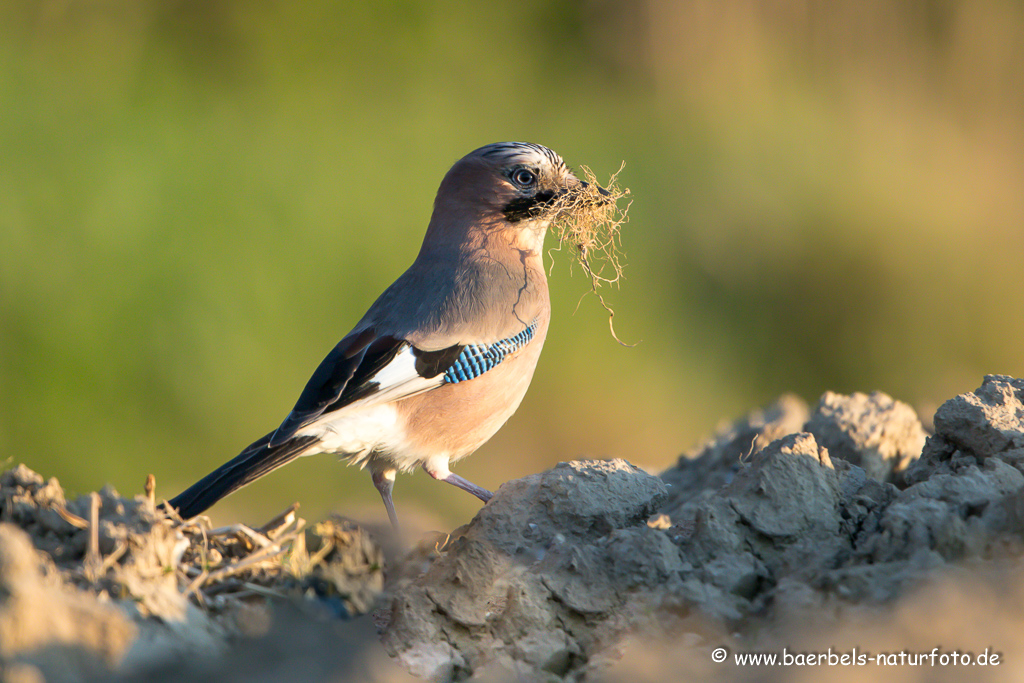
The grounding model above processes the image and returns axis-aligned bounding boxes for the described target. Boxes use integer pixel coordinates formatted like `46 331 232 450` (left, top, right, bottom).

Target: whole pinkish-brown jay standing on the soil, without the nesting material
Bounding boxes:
168 142 608 529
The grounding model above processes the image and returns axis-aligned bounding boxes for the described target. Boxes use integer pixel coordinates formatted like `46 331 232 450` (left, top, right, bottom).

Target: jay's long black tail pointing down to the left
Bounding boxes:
169 432 316 519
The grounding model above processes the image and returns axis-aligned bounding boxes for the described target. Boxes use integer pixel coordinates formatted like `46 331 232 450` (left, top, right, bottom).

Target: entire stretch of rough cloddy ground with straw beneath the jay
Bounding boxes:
0 376 1024 683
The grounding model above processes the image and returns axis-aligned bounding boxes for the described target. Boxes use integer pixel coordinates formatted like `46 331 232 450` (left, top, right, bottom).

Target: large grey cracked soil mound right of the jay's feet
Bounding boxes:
384 376 1024 681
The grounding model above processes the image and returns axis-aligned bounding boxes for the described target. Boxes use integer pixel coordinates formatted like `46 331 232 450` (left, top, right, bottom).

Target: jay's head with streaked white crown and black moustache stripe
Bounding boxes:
428 142 607 252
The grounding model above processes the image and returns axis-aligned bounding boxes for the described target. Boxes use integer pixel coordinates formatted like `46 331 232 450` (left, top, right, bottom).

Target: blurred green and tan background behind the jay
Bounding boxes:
0 0 1024 524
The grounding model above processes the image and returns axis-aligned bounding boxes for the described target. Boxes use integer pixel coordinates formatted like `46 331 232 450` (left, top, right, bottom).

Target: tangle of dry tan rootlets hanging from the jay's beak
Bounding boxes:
550 164 633 346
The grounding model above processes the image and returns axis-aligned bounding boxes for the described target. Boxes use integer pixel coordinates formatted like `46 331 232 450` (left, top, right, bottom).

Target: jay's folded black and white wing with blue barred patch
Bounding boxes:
269 322 538 447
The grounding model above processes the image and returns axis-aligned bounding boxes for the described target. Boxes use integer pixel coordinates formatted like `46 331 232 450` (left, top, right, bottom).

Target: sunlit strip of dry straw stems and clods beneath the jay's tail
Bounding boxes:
0 465 384 621
